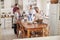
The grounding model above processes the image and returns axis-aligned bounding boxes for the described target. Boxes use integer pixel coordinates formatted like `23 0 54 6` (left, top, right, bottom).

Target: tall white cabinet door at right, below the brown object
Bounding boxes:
49 4 59 36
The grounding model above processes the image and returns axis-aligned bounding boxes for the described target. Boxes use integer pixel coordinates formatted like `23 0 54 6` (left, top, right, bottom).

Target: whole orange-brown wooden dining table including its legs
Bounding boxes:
18 21 48 38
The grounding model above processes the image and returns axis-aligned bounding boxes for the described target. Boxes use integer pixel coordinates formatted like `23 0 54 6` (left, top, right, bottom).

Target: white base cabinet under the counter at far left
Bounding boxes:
1 18 12 28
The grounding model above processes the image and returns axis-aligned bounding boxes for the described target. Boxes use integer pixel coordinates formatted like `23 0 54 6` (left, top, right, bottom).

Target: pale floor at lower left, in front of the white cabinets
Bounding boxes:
1 28 17 40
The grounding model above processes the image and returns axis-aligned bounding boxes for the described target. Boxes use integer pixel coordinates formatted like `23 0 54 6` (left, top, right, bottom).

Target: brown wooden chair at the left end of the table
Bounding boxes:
17 23 27 38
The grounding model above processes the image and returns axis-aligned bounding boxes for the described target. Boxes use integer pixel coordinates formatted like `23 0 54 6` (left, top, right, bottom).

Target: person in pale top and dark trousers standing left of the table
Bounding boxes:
13 8 20 34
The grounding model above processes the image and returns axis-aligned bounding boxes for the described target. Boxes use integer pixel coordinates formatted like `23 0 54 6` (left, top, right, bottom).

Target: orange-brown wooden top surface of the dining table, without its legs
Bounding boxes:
18 21 47 29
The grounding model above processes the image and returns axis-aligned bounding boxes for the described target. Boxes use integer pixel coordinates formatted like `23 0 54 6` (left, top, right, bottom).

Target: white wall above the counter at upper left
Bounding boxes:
1 0 15 14
